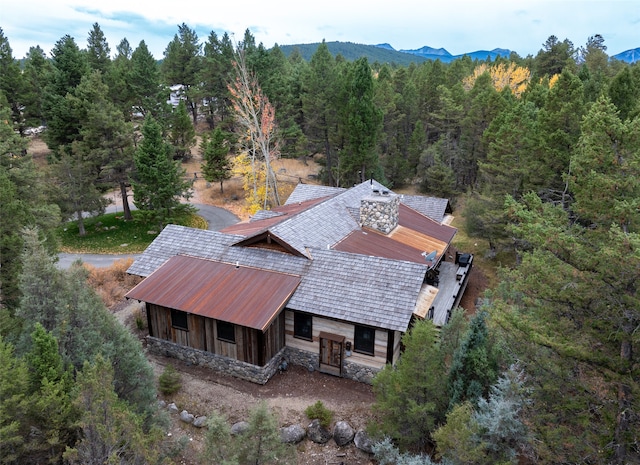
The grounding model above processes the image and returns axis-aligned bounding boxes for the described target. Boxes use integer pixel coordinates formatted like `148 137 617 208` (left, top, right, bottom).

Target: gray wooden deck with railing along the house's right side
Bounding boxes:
432 257 473 327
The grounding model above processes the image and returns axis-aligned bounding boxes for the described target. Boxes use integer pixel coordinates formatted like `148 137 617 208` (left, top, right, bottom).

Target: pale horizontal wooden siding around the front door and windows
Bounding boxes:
284 310 388 368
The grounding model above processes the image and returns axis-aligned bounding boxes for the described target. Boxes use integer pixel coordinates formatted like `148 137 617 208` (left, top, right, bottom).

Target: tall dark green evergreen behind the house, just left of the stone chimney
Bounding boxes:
340 57 385 186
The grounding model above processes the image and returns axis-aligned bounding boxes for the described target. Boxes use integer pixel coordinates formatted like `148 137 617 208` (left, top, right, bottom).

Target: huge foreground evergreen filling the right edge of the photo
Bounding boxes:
493 97 640 463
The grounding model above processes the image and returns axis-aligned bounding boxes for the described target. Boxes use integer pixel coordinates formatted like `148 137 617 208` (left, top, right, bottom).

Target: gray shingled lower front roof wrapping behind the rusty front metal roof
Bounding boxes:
128 225 426 331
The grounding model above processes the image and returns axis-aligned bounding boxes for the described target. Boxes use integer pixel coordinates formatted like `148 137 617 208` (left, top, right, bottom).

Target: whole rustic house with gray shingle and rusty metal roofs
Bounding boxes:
127 180 472 384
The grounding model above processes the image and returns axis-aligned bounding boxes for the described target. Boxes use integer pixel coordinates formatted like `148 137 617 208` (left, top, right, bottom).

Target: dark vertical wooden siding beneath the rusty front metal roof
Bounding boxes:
147 304 285 366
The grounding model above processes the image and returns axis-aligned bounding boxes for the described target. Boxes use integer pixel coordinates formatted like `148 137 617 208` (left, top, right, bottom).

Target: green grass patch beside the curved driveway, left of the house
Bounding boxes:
58 210 207 254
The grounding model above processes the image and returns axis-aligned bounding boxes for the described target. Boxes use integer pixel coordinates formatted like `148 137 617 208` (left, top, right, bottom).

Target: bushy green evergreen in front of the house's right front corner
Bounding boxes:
371 321 447 451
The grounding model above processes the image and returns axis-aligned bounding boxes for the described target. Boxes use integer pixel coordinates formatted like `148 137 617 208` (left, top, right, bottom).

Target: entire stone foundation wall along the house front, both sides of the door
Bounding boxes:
146 336 380 384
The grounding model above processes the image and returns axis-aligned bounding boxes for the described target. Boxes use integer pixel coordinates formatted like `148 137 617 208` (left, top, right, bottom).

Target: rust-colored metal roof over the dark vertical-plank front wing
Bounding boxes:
126 255 301 331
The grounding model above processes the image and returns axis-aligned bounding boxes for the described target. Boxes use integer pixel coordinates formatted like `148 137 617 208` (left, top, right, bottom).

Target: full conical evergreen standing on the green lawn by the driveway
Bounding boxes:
132 116 191 228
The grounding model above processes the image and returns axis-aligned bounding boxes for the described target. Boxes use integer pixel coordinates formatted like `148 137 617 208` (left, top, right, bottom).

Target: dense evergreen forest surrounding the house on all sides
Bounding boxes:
0 20 640 464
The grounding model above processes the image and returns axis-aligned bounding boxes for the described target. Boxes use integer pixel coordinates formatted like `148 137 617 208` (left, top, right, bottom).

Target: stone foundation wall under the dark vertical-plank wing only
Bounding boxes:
147 336 286 384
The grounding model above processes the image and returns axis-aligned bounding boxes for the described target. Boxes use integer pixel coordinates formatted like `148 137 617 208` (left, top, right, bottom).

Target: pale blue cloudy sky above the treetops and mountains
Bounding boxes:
0 0 640 59
